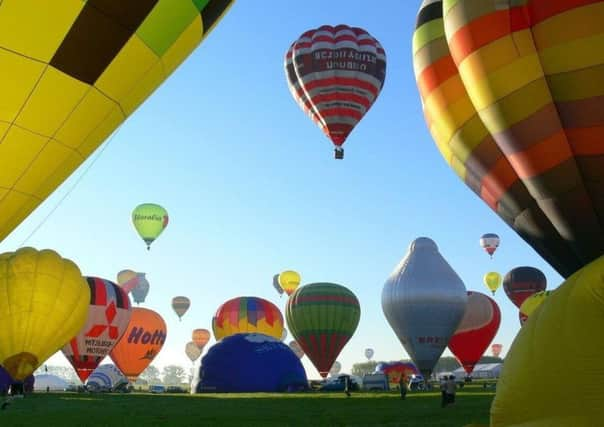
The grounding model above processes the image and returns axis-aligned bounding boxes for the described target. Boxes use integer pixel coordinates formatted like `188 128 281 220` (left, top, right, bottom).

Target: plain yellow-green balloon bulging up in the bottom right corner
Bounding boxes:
491 256 604 427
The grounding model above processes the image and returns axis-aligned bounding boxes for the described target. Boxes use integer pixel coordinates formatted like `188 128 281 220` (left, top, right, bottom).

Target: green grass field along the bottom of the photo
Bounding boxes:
0 386 494 427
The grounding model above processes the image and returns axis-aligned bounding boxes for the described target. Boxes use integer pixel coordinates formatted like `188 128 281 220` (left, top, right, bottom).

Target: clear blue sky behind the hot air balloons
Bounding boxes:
0 0 562 378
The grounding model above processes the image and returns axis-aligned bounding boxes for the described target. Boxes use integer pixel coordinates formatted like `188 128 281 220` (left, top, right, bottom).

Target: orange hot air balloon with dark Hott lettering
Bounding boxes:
109 307 167 382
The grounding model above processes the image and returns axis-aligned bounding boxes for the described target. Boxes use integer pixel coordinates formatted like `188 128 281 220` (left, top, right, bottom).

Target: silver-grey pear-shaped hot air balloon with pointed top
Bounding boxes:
382 237 468 378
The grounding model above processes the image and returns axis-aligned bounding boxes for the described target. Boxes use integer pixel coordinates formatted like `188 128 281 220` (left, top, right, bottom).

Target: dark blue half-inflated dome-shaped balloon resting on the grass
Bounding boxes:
195 334 308 393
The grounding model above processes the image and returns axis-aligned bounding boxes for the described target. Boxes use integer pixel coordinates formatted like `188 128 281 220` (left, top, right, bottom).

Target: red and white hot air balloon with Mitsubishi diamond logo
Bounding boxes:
62 277 132 382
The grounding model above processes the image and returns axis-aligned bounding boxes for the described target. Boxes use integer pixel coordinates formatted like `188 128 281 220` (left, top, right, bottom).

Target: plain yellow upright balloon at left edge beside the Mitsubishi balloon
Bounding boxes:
0 247 90 380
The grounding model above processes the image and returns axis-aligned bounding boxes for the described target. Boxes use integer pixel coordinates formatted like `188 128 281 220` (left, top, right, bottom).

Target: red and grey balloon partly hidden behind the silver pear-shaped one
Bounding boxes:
449 291 501 375
